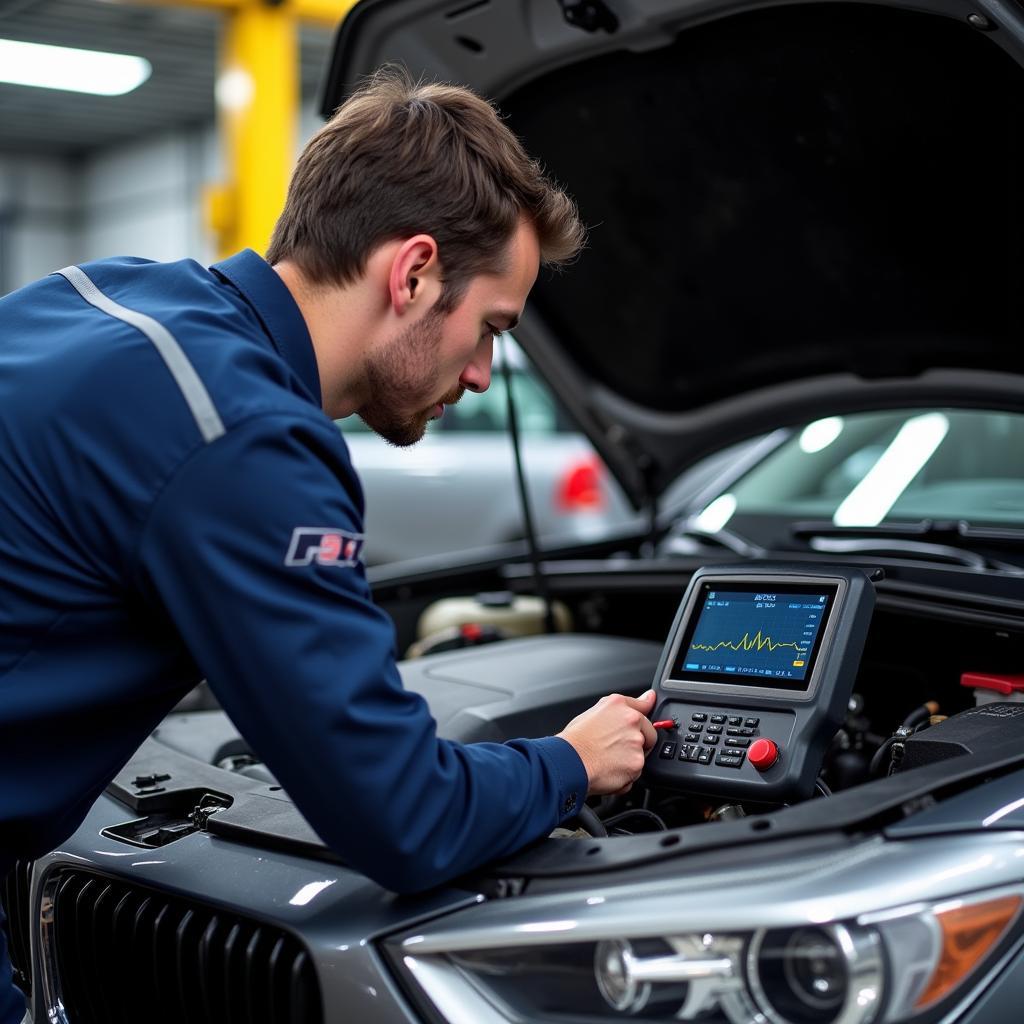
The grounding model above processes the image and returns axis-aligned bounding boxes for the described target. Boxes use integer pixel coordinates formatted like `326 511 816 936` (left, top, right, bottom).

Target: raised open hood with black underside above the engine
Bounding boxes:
323 0 1024 506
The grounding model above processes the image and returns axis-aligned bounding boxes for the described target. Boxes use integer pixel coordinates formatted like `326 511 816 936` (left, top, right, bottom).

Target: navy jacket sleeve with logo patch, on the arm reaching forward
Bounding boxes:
137 417 587 892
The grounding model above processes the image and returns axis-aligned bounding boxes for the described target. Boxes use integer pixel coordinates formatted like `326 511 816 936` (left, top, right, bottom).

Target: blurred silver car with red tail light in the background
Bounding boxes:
338 344 636 565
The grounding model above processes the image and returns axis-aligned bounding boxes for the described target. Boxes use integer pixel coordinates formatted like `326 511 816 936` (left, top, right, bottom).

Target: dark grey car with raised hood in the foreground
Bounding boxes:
4 0 1024 1024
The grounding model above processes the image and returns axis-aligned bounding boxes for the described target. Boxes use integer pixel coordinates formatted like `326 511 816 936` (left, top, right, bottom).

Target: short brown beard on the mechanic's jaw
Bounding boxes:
358 309 465 447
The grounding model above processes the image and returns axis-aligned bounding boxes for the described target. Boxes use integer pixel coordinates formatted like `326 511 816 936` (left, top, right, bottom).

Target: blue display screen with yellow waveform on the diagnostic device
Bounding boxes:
682 591 827 679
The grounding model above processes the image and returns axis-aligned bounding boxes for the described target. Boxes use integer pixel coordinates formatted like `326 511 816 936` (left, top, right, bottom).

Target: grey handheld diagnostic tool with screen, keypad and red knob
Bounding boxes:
644 565 874 803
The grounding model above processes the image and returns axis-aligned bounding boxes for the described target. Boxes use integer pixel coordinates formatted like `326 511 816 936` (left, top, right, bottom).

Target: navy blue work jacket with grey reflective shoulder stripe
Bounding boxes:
0 251 587 1024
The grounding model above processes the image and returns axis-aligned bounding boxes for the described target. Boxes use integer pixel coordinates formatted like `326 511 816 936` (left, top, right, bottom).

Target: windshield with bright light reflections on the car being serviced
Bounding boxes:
697 410 1024 529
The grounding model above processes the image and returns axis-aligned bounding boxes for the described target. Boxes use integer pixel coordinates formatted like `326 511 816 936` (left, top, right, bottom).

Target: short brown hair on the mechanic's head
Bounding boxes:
266 66 585 311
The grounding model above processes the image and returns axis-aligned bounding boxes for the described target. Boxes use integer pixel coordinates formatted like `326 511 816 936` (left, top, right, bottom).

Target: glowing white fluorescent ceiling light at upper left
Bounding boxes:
0 39 153 96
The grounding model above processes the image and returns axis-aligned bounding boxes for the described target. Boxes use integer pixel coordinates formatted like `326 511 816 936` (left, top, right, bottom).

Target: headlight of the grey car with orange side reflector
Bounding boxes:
389 890 1022 1024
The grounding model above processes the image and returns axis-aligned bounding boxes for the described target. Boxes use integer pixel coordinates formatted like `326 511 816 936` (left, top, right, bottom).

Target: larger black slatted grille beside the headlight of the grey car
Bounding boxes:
53 870 323 1024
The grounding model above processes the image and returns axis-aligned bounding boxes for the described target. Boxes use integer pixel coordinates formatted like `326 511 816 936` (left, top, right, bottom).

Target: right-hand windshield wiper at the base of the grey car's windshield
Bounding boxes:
790 519 1024 572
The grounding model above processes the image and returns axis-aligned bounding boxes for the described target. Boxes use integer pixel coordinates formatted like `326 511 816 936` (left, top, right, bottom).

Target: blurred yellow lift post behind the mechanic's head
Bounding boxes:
125 0 356 256
